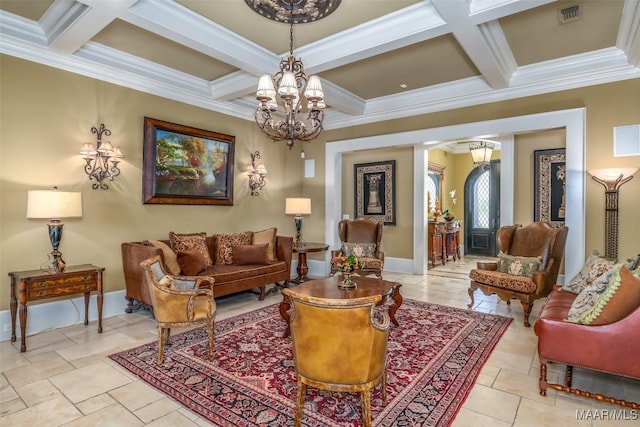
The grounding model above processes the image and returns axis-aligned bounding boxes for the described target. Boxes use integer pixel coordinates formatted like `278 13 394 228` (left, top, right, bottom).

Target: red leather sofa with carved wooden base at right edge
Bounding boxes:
534 286 640 409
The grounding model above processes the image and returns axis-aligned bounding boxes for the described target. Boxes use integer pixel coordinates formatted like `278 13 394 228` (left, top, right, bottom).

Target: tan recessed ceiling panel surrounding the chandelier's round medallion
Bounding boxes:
176 0 422 55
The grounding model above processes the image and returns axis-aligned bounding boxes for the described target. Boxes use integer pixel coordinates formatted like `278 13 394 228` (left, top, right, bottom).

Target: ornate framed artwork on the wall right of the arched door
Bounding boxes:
533 148 567 227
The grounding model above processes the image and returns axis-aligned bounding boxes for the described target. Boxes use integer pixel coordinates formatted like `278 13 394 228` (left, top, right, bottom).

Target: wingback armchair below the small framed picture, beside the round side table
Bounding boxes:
329 218 384 279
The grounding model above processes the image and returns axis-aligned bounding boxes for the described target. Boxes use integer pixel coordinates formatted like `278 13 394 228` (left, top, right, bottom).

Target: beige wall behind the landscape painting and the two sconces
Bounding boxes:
0 56 304 310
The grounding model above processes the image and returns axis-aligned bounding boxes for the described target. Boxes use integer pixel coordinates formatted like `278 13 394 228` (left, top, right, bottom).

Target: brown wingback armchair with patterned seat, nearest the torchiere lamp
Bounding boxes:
468 222 569 327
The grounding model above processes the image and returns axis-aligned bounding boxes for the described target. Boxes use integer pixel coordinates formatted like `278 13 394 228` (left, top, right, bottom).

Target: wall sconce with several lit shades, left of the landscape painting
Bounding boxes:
80 124 124 190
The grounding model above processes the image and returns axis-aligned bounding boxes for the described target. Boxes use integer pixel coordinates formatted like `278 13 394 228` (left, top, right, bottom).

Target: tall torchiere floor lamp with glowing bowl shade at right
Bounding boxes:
587 168 638 260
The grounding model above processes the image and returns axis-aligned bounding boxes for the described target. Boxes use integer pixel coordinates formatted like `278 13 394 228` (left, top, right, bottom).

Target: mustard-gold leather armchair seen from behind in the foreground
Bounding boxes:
282 288 389 427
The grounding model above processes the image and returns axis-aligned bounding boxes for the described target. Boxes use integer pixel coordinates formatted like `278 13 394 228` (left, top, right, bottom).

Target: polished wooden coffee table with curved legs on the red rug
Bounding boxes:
280 274 402 337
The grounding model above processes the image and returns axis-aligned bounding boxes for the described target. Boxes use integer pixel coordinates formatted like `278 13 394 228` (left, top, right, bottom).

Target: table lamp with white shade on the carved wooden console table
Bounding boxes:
27 187 82 272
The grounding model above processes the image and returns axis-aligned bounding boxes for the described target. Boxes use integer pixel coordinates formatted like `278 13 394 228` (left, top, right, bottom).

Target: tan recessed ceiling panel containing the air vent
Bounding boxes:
500 0 624 66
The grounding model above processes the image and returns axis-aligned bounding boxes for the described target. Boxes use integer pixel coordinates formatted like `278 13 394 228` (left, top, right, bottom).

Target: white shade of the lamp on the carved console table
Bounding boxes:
27 190 82 219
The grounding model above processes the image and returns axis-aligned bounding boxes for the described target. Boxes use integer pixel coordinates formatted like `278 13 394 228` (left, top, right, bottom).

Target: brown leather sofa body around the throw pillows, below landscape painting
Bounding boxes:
121 236 293 313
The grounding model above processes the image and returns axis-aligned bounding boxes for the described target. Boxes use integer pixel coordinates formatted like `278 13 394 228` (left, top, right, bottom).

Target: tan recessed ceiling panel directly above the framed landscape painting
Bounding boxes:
93 20 237 80
